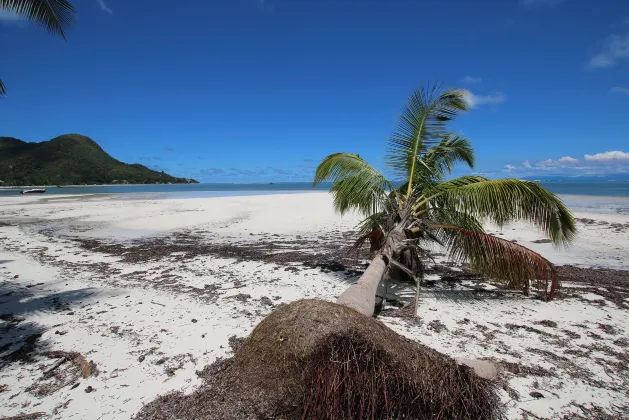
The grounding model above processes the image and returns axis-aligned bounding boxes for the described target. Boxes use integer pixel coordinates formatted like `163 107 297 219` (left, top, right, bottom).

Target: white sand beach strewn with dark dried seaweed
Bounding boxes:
0 192 629 419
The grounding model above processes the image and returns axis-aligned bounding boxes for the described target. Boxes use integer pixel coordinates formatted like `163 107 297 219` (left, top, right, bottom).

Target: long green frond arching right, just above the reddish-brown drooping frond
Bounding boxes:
431 177 577 246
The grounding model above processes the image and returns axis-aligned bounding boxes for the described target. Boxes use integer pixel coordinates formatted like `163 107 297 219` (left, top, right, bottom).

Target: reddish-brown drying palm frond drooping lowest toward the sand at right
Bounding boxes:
435 225 559 299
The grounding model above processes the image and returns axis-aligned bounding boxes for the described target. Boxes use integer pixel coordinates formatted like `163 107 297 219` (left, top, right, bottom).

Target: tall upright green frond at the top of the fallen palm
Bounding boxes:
387 84 468 191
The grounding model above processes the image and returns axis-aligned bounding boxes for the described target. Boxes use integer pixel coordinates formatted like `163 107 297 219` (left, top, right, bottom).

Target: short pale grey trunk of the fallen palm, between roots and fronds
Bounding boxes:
336 225 406 316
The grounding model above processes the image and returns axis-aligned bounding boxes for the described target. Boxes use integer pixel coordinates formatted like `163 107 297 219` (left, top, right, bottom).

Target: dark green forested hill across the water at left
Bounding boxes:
0 134 197 186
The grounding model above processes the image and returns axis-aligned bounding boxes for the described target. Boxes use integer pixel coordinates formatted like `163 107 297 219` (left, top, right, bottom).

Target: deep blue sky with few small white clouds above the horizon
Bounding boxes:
0 0 629 182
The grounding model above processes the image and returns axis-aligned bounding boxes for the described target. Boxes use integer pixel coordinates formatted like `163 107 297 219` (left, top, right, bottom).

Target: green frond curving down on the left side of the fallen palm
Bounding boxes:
312 153 393 216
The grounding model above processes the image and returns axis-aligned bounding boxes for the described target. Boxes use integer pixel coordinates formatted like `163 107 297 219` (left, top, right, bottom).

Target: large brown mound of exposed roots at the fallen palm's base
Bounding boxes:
136 300 502 420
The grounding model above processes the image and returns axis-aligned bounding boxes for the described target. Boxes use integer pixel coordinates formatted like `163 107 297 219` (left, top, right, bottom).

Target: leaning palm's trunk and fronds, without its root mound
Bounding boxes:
314 84 576 316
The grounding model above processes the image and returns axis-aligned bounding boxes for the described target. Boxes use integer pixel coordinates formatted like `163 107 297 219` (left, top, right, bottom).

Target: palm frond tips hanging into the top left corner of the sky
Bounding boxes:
0 0 74 97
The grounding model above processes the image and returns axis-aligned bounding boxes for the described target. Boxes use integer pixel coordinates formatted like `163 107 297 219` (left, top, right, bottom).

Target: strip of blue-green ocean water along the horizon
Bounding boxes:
0 181 629 214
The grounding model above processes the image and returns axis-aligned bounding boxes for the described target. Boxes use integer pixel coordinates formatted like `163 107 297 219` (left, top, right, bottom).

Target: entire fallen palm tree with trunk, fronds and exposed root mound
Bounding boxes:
136 83 575 420
